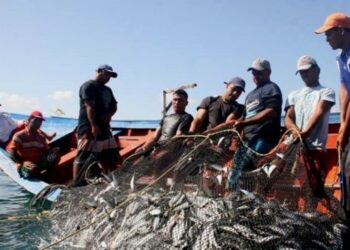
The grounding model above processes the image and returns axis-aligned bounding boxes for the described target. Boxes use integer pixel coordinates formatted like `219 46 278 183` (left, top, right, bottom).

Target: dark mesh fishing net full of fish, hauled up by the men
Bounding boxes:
44 130 348 249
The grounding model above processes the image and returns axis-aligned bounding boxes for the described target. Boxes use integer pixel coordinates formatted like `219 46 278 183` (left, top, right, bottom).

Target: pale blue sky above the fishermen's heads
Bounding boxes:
0 0 350 120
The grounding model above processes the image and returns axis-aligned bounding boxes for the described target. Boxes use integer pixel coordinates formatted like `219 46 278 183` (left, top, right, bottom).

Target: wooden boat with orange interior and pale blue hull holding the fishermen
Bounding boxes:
0 121 340 209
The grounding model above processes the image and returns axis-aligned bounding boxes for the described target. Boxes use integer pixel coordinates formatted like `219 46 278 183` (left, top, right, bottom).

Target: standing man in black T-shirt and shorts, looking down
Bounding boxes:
72 64 120 186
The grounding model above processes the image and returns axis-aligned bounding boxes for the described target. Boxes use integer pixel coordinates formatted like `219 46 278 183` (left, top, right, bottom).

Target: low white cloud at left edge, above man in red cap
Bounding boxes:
0 92 40 112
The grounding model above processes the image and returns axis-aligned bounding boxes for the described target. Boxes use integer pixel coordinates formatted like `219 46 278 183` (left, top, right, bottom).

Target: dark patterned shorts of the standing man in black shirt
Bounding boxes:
74 137 121 166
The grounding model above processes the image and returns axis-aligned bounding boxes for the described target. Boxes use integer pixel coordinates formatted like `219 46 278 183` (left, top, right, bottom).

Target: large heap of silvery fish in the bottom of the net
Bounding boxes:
47 174 345 250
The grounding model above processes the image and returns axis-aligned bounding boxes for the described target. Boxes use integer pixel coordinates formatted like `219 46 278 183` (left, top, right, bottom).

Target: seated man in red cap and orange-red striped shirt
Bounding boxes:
6 111 60 178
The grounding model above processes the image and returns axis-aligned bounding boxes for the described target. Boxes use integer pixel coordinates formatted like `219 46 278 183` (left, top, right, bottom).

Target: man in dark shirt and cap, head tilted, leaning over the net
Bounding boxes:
190 77 245 133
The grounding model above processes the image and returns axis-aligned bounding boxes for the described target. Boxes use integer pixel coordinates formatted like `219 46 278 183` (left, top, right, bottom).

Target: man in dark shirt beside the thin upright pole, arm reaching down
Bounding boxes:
137 89 193 152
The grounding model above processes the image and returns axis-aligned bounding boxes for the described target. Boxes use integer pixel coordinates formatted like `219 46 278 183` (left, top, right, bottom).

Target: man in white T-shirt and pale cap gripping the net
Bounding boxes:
284 56 335 198
